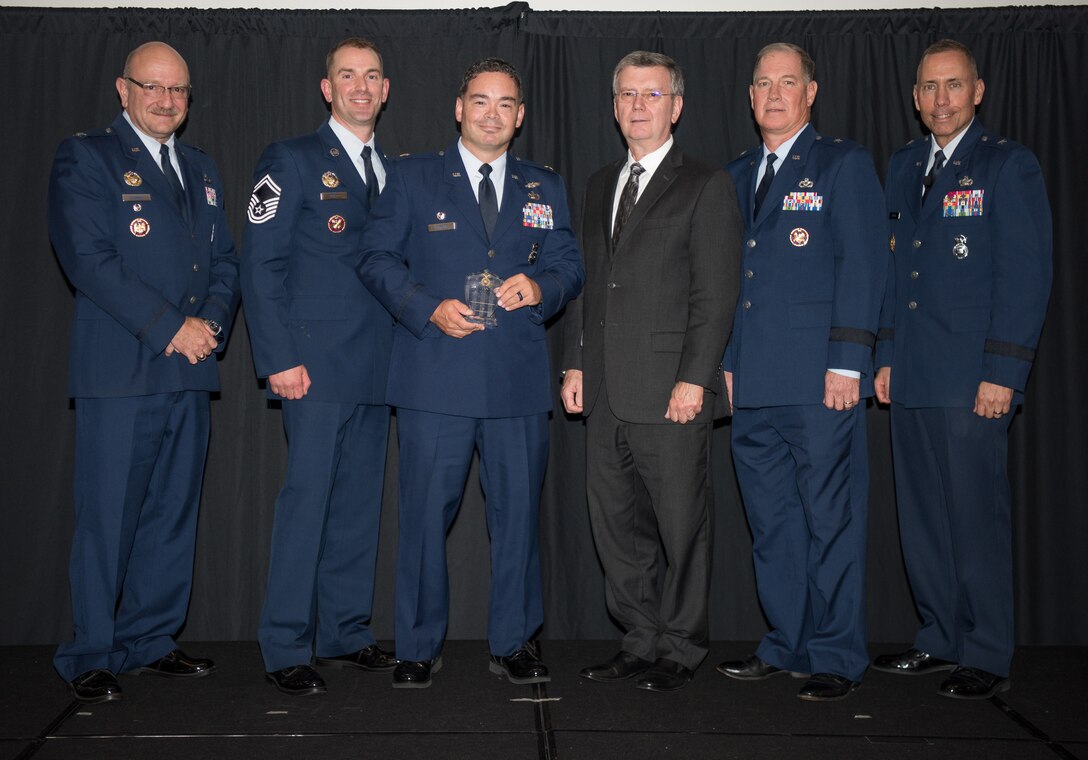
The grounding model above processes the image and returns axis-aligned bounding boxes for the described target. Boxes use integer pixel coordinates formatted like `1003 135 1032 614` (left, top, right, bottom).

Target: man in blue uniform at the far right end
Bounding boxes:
873 39 1051 699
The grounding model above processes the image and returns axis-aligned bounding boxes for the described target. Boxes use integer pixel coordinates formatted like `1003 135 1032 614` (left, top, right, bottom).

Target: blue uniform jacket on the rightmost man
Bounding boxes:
877 119 1052 408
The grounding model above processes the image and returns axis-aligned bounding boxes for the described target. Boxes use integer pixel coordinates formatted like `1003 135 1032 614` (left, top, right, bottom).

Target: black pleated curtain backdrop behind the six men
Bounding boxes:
0 3 1088 645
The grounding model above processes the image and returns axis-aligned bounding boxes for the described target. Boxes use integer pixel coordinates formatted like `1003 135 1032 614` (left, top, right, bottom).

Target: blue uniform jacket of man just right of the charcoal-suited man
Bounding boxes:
722 125 888 408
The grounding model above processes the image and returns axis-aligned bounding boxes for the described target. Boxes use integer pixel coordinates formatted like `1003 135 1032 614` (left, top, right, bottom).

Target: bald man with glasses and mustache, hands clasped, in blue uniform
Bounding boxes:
49 42 238 702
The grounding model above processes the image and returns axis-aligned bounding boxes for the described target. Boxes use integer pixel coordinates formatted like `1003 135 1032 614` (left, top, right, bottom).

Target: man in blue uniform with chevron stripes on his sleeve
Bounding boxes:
242 37 396 696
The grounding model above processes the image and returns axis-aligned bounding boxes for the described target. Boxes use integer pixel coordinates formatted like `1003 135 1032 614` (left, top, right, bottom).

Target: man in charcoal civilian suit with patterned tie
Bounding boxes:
561 51 742 692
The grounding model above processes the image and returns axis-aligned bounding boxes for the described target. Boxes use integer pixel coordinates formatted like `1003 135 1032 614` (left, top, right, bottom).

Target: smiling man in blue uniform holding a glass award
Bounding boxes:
359 59 584 688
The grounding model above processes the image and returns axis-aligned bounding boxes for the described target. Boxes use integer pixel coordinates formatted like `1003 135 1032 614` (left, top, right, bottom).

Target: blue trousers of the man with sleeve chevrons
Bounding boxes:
258 400 390 672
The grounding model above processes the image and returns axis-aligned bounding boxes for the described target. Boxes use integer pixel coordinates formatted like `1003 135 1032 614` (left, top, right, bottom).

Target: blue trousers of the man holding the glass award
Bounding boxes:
396 409 547 660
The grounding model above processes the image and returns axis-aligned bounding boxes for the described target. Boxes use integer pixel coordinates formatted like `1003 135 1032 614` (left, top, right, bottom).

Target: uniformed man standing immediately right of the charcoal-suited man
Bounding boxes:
718 43 887 701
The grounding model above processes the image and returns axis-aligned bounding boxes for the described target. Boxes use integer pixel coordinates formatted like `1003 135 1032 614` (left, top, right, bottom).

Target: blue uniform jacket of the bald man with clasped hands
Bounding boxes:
49 114 238 398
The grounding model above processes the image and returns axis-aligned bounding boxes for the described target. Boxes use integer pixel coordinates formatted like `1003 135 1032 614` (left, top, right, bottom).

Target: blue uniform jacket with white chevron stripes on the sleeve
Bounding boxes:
242 123 393 404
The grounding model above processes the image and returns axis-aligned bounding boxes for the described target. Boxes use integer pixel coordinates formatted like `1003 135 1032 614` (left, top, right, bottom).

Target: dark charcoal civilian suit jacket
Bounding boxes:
562 144 743 424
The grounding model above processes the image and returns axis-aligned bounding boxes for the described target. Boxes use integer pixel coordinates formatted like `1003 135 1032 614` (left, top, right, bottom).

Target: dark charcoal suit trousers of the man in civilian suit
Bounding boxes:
585 384 714 670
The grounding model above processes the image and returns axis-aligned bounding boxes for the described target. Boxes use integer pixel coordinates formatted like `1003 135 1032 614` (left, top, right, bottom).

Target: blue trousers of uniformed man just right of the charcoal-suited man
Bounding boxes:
732 404 869 681
